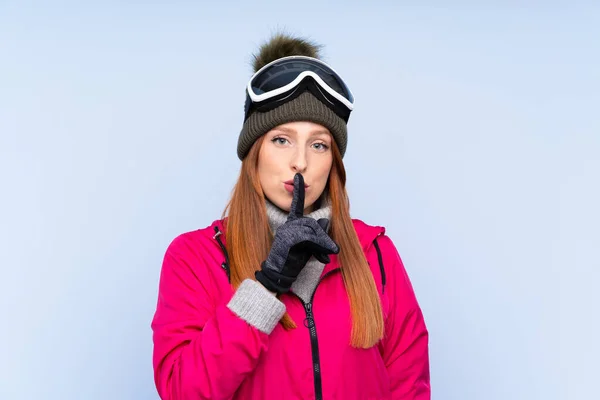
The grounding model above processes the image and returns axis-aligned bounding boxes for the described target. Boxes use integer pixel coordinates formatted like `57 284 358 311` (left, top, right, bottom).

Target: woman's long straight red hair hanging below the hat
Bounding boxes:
224 136 384 348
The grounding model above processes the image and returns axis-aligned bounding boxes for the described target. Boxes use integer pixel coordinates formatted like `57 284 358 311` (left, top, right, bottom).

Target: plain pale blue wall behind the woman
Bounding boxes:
0 1 600 400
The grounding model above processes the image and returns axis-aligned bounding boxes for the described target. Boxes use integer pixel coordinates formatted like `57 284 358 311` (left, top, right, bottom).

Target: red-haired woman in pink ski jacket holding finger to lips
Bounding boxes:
152 35 430 400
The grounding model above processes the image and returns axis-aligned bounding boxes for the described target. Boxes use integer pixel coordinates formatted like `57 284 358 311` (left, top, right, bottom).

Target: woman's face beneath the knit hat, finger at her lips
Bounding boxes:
258 121 333 213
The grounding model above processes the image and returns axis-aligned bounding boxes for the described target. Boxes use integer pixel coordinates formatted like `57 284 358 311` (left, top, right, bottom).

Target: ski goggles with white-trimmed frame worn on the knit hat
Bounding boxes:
244 56 354 122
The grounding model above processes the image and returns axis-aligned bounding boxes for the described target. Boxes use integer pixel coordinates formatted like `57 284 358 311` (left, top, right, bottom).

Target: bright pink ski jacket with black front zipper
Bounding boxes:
152 220 430 400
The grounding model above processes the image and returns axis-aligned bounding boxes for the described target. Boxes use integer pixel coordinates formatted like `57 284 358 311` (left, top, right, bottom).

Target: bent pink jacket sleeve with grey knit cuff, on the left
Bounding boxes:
152 236 285 400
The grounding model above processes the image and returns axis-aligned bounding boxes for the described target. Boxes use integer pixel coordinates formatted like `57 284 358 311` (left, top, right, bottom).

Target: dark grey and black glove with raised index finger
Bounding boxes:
255 173 340 293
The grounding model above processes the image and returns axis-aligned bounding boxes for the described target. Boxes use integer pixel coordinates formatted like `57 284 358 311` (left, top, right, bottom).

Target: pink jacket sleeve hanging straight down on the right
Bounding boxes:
377 235 431 400
